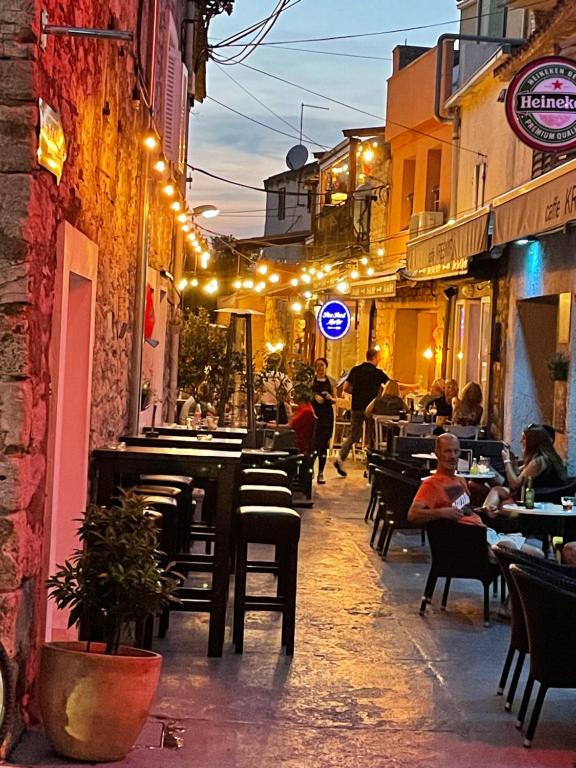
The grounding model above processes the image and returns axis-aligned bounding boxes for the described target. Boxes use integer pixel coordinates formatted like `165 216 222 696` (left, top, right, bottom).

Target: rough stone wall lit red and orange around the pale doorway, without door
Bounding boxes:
0 0 187 743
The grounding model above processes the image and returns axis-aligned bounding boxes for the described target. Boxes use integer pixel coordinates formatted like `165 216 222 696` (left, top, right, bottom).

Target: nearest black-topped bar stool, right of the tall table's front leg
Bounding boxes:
233 506 300 656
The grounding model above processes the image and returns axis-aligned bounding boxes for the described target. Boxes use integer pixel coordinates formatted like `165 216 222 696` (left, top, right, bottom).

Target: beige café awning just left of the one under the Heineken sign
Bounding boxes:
406 207 490 280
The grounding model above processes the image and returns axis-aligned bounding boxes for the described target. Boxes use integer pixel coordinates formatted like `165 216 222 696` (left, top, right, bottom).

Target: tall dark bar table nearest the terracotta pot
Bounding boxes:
90 444 240 656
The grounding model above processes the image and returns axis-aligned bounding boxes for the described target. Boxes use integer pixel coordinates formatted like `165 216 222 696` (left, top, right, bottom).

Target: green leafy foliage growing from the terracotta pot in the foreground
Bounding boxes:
47 493 178 654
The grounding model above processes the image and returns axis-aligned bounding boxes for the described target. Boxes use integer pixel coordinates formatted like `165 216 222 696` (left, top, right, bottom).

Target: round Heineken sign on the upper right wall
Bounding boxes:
506 56 576 152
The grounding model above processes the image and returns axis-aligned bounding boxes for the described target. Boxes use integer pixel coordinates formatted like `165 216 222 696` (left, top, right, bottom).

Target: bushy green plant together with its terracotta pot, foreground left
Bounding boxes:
39 493 177 762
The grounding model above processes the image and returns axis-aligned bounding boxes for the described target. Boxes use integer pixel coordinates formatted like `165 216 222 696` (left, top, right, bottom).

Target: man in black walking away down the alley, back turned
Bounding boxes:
334 349 388 477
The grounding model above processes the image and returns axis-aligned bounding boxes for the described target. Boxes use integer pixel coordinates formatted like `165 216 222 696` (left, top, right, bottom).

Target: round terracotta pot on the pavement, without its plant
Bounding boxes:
39 642 162 763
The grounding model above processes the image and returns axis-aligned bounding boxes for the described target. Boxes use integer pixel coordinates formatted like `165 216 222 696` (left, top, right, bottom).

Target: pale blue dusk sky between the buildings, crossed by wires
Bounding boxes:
188 0 458 237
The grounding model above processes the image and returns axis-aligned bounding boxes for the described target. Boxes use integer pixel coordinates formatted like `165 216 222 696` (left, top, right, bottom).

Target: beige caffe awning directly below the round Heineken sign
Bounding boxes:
492 160 576 245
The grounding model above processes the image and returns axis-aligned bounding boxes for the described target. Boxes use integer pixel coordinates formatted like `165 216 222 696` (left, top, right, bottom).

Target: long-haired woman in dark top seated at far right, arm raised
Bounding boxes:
484 425 566 509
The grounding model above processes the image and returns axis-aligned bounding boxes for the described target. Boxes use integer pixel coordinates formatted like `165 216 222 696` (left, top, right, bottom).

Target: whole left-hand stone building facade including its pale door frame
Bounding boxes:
0 0 232 751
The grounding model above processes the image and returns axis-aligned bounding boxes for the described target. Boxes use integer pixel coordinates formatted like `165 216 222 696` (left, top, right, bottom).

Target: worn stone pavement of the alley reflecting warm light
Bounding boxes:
11 462 576 768
